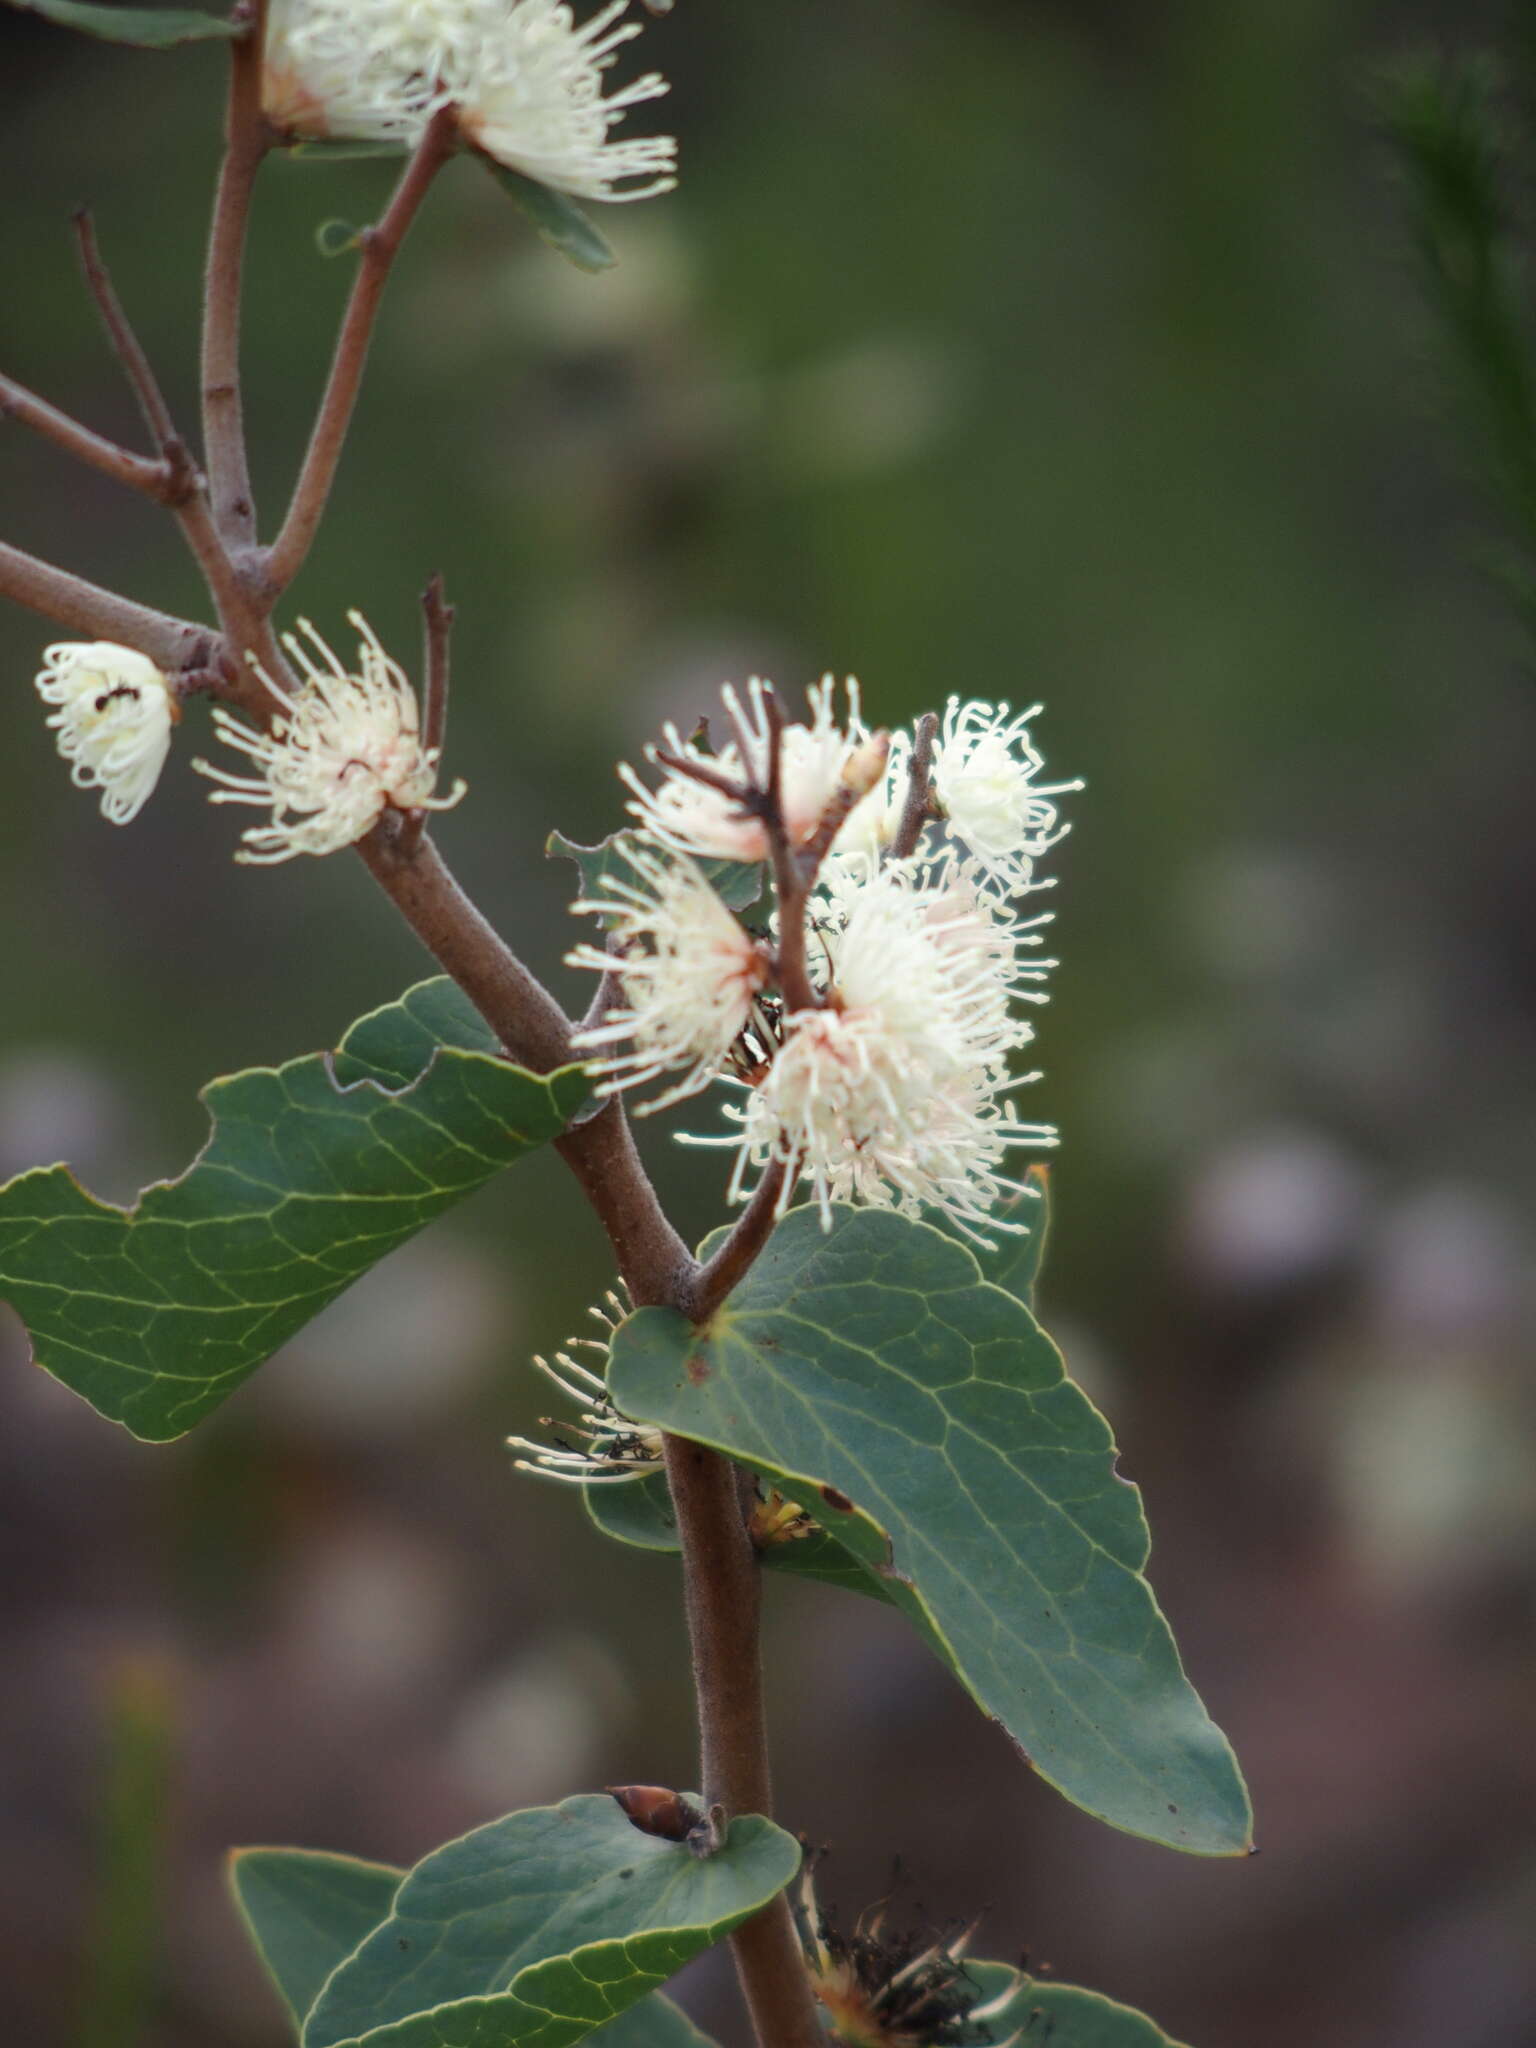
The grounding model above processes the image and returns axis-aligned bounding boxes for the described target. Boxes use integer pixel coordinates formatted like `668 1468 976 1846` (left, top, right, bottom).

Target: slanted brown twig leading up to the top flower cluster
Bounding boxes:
266 106 457 592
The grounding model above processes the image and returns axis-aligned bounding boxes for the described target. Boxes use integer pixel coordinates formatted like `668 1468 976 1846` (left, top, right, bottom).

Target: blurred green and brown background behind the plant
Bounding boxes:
0 0 1536 2048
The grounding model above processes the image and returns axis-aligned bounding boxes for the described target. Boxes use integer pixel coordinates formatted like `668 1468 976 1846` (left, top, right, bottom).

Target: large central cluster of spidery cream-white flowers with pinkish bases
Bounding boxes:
569 678 1079 1241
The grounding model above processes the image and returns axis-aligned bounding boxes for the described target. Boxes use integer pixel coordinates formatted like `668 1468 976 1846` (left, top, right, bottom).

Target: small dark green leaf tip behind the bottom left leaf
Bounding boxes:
229 1849 406 2025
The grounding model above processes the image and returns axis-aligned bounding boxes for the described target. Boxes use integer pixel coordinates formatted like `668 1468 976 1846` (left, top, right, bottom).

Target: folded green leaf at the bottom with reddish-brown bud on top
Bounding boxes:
303 1794 801 2048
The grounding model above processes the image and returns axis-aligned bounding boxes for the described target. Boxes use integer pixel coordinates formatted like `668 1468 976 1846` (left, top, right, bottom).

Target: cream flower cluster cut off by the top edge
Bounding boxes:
262 0 678 199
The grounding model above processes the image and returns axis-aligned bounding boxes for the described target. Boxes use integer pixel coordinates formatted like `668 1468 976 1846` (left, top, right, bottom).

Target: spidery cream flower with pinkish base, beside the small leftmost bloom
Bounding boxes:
193 612 465 864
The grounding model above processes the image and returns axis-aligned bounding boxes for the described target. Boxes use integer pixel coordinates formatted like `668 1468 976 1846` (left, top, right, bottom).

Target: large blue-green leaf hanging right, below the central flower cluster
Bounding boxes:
608 1208 1249 1855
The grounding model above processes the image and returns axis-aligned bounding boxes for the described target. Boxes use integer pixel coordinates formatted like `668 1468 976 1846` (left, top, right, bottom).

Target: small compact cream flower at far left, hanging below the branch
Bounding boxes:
37 641 180 825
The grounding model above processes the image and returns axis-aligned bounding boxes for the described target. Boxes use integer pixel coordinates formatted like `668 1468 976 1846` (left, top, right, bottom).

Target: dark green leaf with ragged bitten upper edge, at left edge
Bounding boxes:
0 981 590 1442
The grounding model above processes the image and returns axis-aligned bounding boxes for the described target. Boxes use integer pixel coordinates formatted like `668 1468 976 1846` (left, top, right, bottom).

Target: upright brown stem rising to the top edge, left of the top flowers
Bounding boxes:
203 0 272 547
